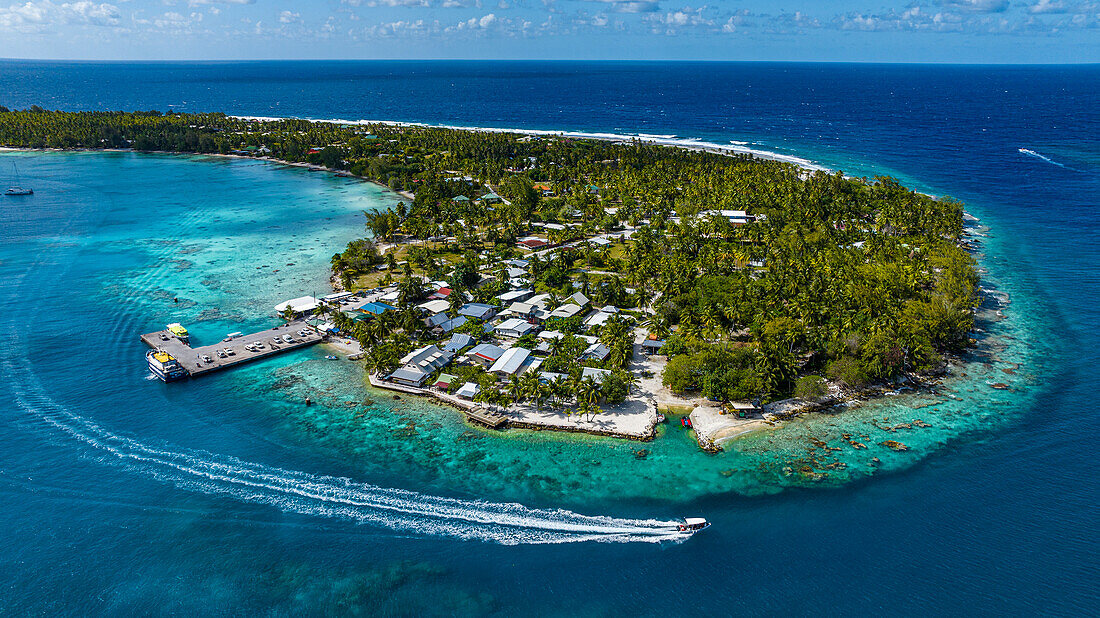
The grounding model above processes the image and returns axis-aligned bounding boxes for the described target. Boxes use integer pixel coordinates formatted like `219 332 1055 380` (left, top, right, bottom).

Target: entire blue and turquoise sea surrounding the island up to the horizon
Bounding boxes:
0 60 1100 616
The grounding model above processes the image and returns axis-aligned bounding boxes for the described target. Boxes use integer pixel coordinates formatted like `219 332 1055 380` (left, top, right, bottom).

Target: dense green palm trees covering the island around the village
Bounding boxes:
0 109 977 400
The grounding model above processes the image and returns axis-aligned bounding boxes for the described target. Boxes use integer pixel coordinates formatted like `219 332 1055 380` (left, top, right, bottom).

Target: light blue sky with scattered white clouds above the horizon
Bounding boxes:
0 0 1100 63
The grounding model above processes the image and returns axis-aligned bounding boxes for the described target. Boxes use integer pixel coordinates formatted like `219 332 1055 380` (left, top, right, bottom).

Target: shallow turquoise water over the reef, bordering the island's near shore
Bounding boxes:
4 153 1030 507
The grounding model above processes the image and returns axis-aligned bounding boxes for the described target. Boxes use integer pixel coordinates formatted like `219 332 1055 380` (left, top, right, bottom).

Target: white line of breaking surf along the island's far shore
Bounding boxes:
232 115 831 172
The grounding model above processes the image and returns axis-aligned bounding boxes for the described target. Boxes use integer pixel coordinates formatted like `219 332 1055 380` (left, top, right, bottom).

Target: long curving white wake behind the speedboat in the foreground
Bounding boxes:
3 362 686 545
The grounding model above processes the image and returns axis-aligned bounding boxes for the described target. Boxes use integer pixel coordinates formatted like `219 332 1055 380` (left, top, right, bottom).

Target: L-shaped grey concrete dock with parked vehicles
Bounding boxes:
141 321 323 377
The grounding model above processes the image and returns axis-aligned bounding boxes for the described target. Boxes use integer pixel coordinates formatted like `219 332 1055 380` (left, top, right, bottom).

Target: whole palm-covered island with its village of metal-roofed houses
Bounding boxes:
0 109 981 452
